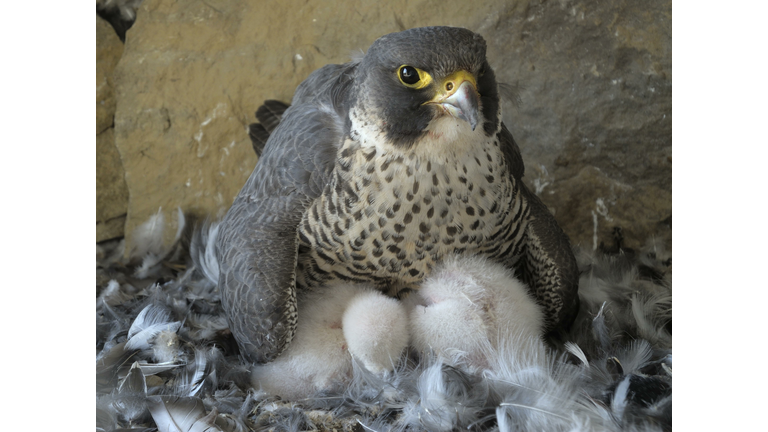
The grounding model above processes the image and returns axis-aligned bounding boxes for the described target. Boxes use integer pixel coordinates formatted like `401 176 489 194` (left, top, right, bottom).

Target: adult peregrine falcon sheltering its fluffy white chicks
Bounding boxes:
217 27 579 363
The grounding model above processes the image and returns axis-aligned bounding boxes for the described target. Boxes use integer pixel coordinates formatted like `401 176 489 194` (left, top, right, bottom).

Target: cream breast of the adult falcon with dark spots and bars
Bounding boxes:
297 116 528 295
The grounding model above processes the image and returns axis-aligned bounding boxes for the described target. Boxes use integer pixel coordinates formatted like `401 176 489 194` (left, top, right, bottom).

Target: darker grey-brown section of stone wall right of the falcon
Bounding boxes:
478 0 672 248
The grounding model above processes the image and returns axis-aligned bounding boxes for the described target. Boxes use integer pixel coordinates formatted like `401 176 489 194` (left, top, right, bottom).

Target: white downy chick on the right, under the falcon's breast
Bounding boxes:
408 256 544 369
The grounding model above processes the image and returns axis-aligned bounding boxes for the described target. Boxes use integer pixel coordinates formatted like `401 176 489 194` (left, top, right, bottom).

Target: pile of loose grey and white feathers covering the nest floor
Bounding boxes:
96 213 672 432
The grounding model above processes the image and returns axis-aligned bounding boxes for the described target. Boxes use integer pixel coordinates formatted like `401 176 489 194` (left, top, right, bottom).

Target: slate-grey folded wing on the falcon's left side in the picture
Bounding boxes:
218 98 341 363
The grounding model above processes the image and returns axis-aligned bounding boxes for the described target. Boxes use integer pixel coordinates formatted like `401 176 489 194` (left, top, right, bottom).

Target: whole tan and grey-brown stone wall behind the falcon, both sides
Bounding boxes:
103 0 672 253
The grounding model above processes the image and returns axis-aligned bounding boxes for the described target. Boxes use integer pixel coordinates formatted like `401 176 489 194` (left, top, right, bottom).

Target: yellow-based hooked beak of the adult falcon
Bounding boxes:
427 71 479 131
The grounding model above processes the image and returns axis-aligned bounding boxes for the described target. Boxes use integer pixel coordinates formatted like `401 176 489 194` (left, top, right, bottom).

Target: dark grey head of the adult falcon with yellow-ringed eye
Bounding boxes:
356 27 500 148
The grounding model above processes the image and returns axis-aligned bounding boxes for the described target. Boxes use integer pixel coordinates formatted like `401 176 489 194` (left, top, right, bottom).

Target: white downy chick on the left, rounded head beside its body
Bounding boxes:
251 284 408 401
